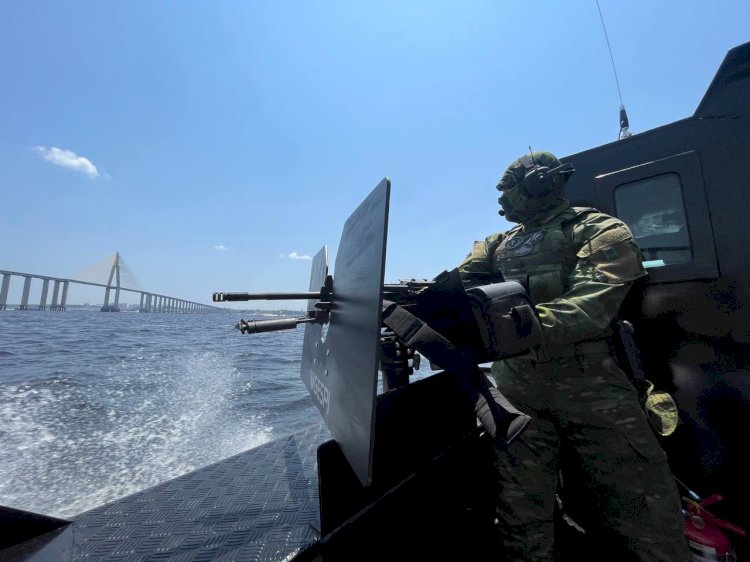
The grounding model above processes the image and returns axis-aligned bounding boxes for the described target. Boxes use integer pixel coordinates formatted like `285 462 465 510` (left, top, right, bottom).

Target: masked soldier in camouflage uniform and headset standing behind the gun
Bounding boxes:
460 152 691 562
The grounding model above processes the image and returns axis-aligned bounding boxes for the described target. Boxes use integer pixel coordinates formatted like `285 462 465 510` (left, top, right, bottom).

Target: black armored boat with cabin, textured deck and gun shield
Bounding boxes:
0 43 750 561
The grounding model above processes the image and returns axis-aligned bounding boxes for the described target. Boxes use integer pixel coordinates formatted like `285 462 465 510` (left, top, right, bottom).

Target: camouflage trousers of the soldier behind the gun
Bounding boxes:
492 346 692 562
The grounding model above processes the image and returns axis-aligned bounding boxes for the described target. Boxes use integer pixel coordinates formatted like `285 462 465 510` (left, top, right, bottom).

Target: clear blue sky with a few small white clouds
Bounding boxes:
0 0 750 308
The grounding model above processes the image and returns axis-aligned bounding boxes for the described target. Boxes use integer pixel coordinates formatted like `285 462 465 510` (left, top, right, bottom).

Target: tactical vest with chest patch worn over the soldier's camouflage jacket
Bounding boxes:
492 207 597 303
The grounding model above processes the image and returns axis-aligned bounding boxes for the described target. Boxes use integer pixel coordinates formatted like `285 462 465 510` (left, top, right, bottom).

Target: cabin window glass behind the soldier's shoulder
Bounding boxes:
614 173 693 267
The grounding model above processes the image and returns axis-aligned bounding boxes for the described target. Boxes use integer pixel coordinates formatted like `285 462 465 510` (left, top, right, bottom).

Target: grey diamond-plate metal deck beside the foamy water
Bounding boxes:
72 425 330 562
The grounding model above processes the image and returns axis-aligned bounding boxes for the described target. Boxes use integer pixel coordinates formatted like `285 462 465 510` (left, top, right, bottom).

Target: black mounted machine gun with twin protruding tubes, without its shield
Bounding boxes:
213 270 541 391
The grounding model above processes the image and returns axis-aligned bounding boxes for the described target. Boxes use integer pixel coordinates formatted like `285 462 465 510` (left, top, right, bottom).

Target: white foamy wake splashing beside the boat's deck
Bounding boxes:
0 351 272 517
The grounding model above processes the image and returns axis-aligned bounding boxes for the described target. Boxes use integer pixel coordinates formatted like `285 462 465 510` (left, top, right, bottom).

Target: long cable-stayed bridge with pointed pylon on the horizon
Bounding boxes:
0 252 224 313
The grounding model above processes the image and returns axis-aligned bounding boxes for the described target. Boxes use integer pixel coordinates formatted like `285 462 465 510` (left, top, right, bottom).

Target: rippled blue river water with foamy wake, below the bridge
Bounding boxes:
0 309 321 517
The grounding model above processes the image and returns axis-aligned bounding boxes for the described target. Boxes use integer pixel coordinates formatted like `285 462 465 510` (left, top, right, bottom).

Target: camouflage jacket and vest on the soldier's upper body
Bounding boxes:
459 206 646 350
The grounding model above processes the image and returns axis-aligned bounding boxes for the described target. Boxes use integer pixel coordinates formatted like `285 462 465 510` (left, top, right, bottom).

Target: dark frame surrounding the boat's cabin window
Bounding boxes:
594 150 719 283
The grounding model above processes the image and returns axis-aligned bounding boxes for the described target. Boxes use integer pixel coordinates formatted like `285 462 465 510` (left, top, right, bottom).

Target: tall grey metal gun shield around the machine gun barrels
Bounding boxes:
301 179 391 486
